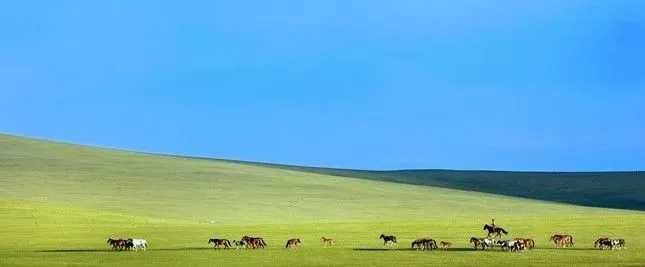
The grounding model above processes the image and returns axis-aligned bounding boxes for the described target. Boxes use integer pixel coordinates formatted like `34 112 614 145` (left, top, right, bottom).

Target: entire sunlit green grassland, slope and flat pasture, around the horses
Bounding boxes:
0 135 645 266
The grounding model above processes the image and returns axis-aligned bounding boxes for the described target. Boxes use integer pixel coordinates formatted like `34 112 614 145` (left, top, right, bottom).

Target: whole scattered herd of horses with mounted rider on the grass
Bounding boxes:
107 220 625 252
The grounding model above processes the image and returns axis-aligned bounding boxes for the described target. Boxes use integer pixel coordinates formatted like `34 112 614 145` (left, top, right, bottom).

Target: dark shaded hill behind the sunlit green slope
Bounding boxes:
223 161 645 210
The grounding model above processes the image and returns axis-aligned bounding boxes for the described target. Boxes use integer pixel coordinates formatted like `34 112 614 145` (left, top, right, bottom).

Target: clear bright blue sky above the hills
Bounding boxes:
0 0 645 171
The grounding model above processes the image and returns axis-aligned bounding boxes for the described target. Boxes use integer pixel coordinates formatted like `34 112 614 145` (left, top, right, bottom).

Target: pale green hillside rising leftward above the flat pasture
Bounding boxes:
0 135 624 223
